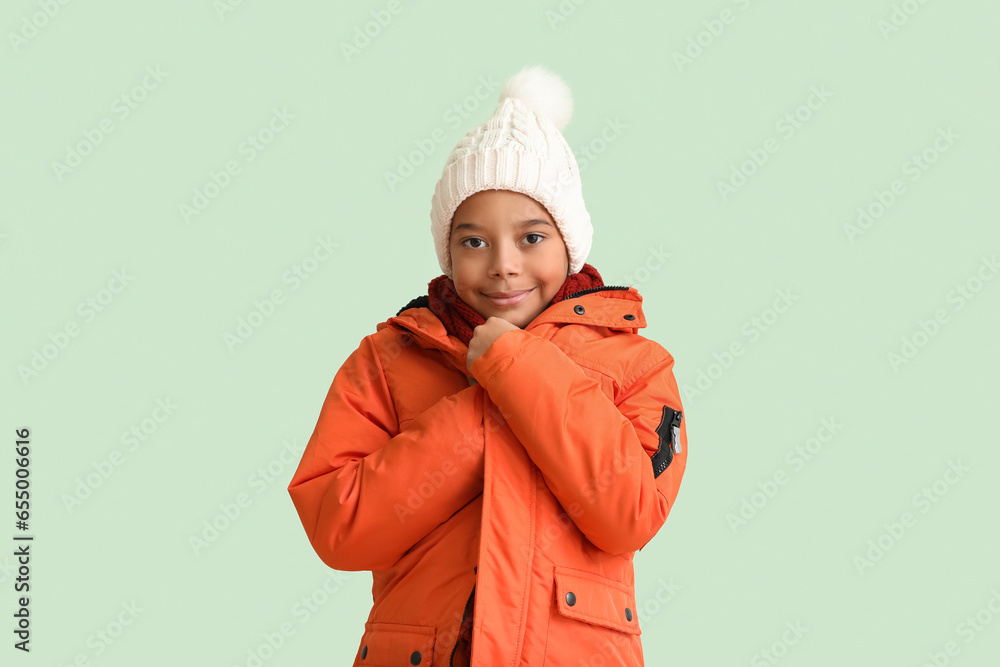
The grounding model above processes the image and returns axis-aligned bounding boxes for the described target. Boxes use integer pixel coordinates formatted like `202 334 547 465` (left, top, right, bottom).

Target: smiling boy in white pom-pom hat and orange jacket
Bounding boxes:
288 67 687 667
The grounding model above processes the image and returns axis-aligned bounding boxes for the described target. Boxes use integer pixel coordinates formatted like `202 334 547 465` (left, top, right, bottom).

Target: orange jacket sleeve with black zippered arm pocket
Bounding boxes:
470 330 687 554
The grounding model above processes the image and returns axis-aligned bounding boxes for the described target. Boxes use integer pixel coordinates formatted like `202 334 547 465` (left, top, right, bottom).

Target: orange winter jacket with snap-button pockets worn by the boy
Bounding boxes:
288 287 687 667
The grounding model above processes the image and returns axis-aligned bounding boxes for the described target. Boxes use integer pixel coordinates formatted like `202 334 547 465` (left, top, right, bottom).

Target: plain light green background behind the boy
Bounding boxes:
0 0 1000 667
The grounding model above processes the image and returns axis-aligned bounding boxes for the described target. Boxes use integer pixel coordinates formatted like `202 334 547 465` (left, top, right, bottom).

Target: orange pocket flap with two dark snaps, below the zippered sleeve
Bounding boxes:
553 565 642 635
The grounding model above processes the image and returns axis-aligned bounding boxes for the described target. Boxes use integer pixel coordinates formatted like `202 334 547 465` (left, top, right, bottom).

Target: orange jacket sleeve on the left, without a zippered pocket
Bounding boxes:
288 336 484 570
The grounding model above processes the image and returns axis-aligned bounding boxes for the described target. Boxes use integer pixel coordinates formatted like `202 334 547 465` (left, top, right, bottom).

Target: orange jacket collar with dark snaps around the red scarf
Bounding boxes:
376 285 646 361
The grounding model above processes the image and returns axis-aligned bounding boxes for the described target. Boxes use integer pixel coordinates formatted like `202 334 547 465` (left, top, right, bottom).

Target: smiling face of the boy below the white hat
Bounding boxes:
449 190 569 328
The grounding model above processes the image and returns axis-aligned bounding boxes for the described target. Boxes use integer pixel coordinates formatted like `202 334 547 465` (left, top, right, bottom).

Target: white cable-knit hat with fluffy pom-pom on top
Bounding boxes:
431 66 594 278
